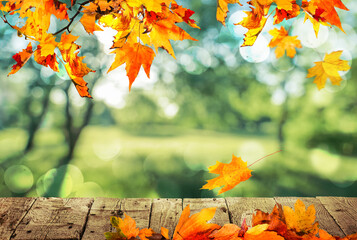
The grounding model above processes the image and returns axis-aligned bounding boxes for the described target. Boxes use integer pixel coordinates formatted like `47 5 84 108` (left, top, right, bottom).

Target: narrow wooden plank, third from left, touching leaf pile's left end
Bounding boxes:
82 198 122 240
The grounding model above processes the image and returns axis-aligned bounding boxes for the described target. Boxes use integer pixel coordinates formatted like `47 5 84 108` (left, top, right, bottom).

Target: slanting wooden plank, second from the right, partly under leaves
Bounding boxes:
275 197 344 237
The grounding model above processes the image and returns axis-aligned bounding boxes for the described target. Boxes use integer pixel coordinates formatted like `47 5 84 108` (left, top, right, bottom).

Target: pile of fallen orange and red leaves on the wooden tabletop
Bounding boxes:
105 200 357 240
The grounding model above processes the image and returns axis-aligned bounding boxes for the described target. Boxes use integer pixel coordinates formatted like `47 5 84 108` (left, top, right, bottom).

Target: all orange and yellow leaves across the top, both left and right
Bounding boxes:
0 0 350 97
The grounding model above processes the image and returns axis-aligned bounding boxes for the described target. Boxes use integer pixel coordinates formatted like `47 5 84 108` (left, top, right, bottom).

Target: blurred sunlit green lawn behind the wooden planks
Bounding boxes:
0 126 357 197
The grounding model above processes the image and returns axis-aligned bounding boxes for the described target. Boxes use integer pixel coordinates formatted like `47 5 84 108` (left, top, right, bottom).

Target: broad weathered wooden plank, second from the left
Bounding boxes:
12 198 93 240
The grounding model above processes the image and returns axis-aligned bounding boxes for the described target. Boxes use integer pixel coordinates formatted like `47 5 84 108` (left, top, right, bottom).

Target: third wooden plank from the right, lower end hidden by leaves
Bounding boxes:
226 197 275 226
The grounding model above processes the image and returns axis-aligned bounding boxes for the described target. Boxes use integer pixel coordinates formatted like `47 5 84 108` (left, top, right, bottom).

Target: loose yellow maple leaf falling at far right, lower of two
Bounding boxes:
306 51 351 89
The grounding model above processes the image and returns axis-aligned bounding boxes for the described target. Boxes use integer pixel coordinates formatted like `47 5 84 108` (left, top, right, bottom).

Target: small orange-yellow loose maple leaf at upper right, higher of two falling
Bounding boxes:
269 26 302 58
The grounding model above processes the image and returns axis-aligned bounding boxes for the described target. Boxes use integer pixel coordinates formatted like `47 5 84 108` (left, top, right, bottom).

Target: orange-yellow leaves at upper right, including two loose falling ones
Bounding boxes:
217 0 350 89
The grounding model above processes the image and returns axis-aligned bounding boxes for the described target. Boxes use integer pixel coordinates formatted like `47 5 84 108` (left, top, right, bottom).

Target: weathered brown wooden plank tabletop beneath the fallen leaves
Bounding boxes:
0 197 357 240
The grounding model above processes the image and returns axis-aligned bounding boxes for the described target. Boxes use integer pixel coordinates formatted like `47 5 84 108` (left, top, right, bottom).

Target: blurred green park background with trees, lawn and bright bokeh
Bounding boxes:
0 0 357 198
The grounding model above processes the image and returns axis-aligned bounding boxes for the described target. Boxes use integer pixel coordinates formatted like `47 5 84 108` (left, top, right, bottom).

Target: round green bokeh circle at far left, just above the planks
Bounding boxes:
4 165 34 193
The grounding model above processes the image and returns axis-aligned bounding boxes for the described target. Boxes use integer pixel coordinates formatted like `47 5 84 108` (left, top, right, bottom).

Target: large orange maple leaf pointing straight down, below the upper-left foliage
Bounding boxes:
108 43 155 90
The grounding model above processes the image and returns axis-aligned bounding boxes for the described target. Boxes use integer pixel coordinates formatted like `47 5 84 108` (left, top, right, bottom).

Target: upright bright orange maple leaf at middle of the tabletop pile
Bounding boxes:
173 205 220 240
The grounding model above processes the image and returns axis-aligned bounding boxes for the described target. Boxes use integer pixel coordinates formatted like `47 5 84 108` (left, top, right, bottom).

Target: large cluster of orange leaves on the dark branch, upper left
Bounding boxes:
0 0 198 97
